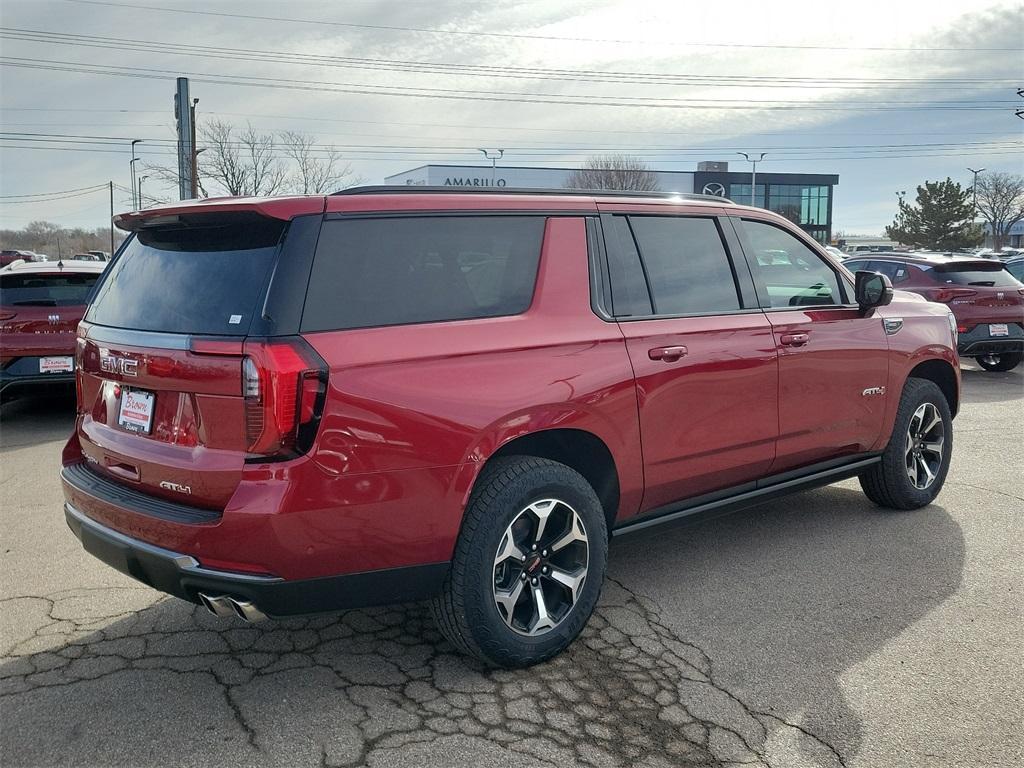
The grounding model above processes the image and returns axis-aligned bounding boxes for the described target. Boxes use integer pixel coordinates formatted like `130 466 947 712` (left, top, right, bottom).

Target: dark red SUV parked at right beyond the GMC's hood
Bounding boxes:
843 252 1024 371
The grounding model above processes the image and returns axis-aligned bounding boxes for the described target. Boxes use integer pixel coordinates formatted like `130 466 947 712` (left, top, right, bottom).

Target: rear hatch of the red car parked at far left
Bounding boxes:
0 265 99 374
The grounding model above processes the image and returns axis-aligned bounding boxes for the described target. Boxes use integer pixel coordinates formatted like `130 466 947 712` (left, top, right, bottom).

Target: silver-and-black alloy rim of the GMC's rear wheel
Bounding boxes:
494 499 590 637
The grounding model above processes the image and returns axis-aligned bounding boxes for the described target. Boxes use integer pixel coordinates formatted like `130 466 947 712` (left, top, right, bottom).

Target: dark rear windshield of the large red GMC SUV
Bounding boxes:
86 216 285 336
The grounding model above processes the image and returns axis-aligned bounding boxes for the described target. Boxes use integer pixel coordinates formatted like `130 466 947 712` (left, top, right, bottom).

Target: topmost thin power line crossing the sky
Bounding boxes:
67 0 1024 52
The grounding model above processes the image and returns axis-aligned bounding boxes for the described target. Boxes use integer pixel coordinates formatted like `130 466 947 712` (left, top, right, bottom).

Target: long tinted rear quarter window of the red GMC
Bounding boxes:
302 216 545 331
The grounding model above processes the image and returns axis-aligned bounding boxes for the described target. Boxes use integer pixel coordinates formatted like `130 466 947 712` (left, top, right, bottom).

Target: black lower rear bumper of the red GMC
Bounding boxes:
65 504 449 617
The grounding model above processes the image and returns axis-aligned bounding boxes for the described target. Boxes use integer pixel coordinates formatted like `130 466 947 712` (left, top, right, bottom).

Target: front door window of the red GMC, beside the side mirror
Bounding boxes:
743 219 843 307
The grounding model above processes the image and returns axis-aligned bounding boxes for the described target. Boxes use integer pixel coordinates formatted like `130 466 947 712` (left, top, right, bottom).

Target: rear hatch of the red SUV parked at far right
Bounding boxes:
929 261 1024 330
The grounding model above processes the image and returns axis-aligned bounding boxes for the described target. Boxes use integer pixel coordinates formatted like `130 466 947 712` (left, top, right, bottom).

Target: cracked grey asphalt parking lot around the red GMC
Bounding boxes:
0 364 1024 768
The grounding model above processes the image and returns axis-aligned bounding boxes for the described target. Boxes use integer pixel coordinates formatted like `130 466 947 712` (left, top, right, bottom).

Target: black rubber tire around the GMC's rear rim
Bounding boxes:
431 456 608 669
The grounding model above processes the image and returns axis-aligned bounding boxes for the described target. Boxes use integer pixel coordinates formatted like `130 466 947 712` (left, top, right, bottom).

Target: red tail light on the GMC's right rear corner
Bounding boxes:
242 337 328 461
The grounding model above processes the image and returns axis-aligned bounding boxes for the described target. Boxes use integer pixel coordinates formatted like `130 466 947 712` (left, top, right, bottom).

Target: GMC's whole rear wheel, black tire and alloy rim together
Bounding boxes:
432 456 608 668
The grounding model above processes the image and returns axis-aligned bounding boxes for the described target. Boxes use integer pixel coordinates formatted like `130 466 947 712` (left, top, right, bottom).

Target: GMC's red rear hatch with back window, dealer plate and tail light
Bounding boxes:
78 213 321 510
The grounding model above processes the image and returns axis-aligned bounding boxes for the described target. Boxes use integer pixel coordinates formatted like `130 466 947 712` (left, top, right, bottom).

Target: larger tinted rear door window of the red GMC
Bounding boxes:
630 216 739 314
